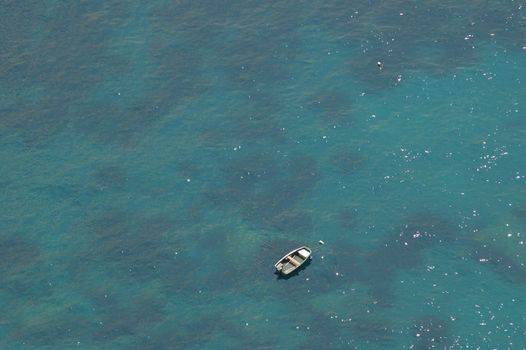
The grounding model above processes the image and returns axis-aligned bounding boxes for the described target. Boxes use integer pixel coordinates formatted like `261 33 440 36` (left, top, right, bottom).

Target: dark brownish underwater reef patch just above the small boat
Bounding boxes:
212 153 320 232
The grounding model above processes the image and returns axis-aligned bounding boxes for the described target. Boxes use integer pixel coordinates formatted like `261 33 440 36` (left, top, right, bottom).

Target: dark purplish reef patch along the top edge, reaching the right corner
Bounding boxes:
312 0 526 93
